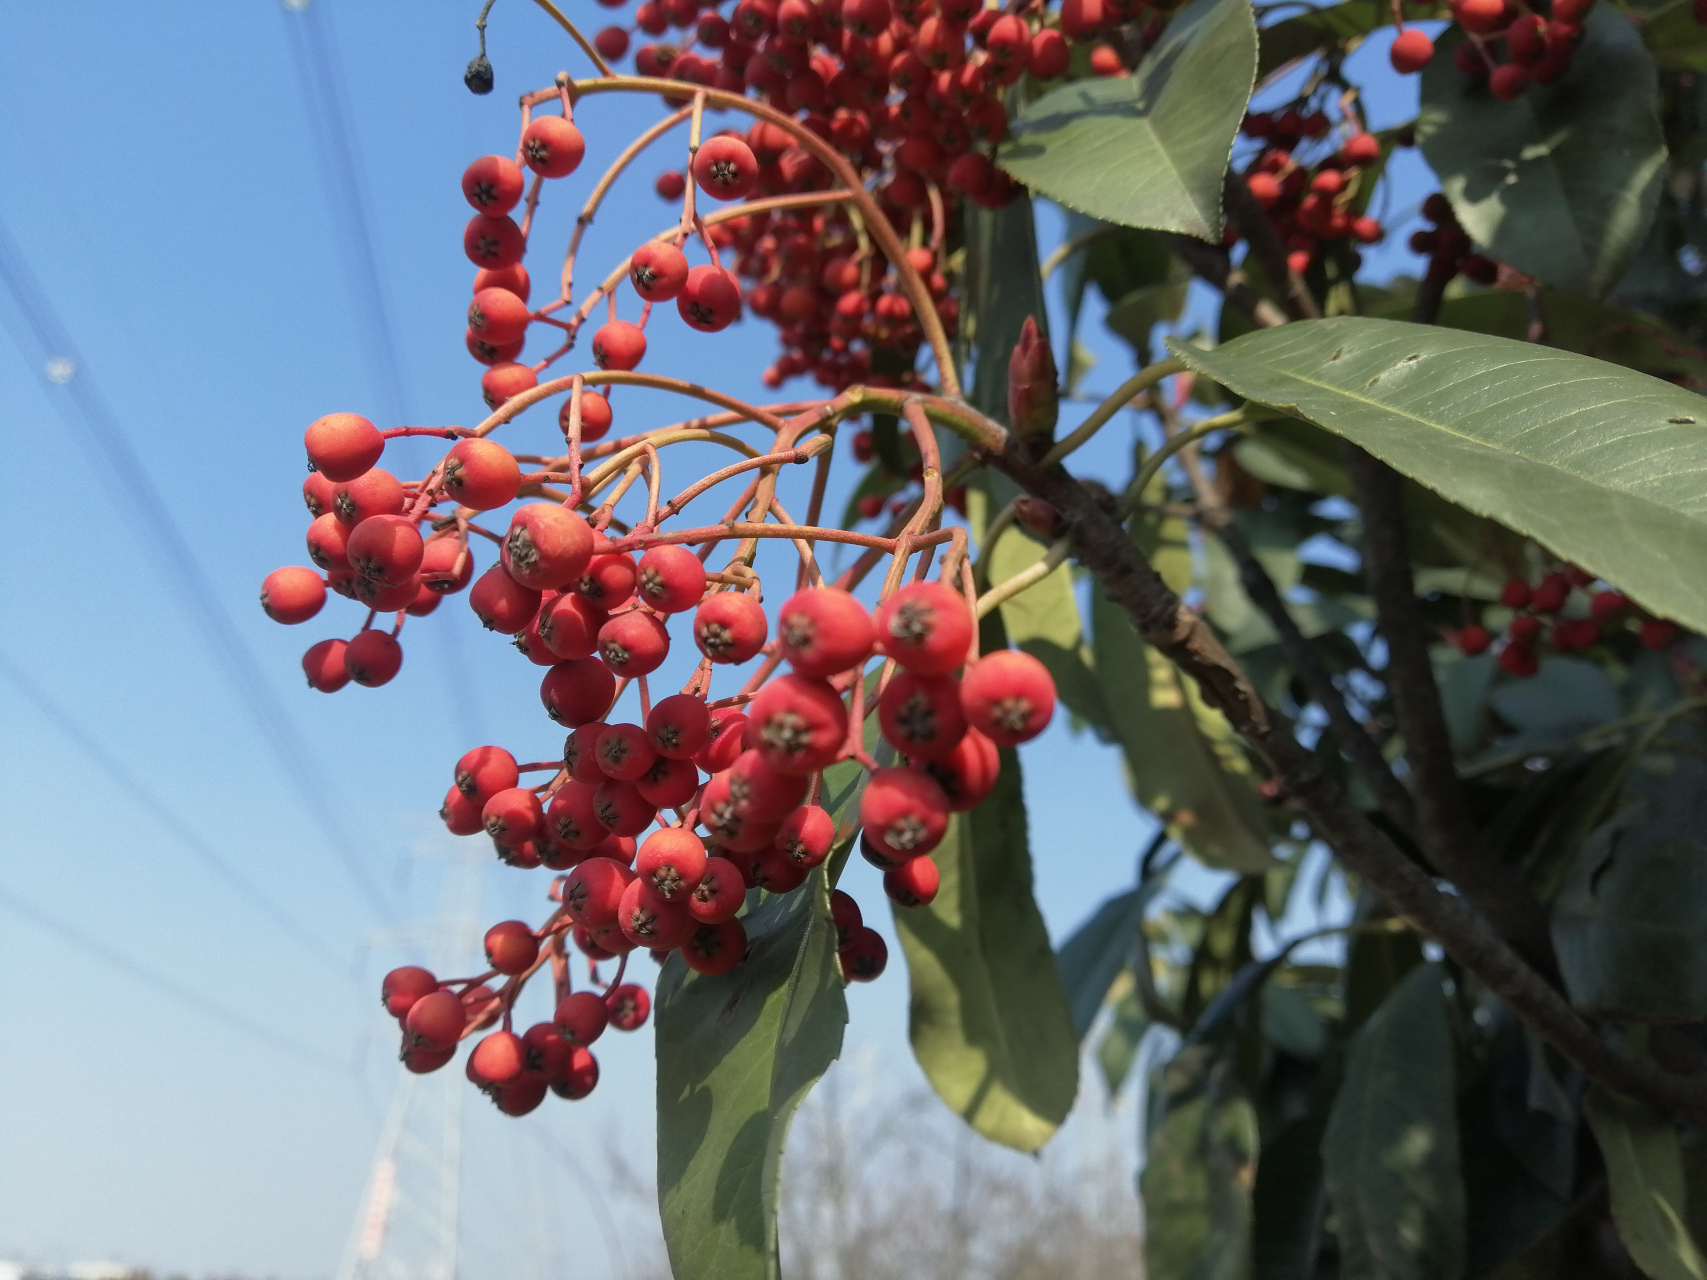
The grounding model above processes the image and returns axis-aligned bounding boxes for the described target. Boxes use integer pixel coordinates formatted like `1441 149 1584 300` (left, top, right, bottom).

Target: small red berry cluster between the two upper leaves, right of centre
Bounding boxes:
1229 109 1381 275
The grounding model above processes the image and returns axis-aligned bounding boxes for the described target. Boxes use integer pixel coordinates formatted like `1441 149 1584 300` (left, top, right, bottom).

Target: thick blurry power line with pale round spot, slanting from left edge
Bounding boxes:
0 220 389 918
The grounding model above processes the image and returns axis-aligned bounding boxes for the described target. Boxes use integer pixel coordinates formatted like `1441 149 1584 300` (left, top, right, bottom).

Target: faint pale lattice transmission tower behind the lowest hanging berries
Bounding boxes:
338 848 483 1280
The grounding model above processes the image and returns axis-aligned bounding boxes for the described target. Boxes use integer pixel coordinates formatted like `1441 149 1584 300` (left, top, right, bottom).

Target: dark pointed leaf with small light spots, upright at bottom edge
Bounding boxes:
1321 964 1465 1280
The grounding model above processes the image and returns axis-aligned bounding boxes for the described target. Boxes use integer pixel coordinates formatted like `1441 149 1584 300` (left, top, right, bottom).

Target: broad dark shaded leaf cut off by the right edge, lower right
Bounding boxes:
1553 778 1707 1022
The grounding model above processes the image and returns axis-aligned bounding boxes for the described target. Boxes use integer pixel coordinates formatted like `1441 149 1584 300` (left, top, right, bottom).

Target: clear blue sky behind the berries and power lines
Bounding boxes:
0 0 1422 1280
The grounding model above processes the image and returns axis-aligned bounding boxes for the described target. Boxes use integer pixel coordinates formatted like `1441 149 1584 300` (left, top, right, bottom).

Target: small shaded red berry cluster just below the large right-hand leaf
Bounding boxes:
1446 565 1681 676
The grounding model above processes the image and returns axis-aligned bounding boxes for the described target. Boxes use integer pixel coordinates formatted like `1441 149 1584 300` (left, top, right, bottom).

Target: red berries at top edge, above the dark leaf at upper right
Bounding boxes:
1389 0 1594 102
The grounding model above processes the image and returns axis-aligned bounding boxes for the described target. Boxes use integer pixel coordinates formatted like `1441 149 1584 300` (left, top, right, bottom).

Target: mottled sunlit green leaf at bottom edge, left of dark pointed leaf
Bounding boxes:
1139 1096 1258 1280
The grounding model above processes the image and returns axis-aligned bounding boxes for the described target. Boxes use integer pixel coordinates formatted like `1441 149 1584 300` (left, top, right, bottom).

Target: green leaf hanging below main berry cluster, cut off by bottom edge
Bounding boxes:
655 869 847 1280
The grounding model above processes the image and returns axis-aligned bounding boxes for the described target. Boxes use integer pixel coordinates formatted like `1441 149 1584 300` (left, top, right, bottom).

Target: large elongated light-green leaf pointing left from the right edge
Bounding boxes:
1169 317 1707 628
